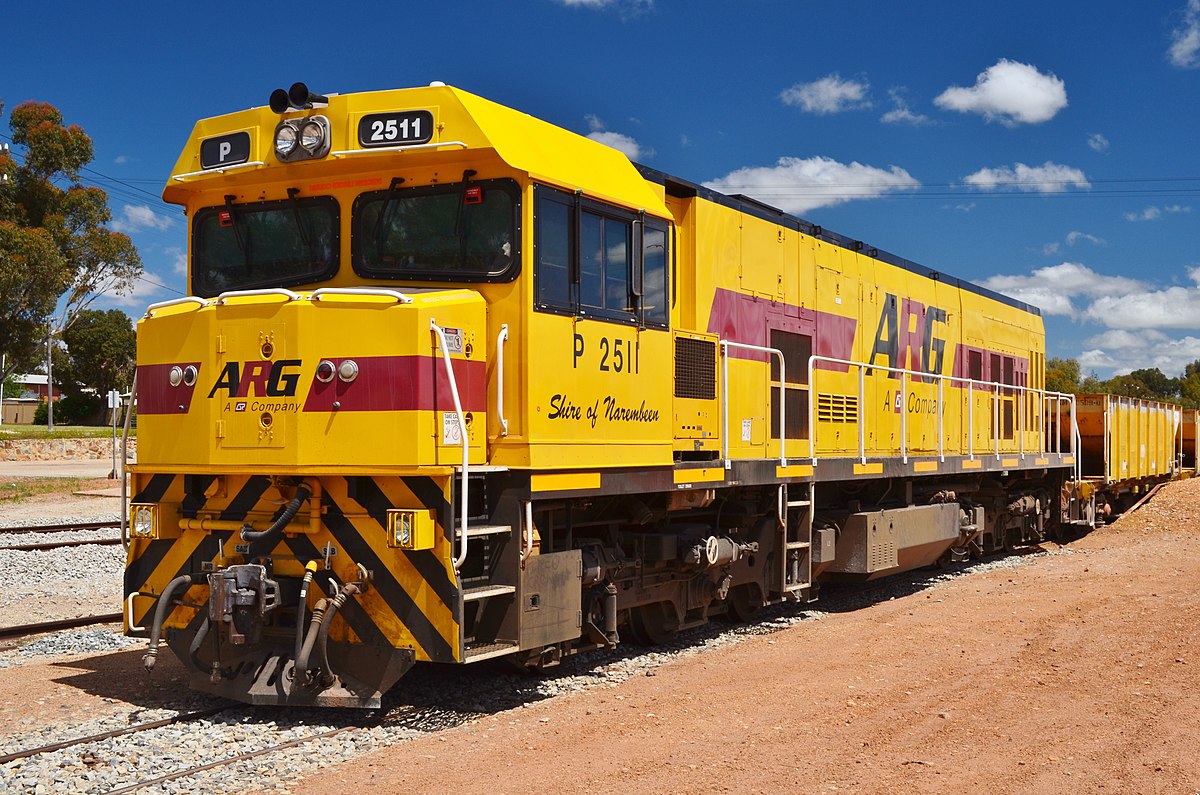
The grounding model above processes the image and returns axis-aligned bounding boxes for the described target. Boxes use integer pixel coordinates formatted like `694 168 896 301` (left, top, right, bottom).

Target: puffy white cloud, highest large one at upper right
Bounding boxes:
934 59 1065 126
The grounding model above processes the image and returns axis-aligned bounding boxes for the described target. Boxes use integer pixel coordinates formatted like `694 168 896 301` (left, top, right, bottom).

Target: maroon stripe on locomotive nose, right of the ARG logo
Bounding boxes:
304 355 487 412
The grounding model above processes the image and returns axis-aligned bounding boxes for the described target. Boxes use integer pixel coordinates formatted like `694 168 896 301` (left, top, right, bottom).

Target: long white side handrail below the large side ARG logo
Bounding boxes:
801 355 1079 480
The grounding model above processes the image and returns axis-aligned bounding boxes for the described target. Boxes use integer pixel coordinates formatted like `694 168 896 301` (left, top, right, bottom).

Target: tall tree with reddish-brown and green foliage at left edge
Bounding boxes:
0 102 142 384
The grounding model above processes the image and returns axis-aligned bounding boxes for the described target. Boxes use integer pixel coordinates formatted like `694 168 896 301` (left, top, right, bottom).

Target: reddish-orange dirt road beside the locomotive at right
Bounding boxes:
295 479 1200 794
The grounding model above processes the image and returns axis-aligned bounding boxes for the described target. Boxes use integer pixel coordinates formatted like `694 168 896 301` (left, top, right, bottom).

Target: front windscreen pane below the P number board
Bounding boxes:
192 196 338 298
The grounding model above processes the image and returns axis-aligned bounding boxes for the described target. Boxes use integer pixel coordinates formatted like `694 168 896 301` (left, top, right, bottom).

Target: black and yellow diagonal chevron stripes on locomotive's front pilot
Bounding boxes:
125 474 463 663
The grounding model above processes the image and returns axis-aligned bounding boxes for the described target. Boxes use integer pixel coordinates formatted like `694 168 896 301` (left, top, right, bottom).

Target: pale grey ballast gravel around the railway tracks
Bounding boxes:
0 518 1070 795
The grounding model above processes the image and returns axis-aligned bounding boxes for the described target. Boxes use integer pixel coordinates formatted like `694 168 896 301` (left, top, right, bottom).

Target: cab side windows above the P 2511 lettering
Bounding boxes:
534 185 670 328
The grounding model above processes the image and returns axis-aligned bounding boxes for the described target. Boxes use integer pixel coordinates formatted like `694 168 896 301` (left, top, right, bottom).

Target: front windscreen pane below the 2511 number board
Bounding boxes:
352 179 521 281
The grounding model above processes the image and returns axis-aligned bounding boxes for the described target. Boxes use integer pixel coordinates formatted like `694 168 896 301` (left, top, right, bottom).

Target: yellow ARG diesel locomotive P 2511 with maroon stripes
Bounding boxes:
125 84 1086 707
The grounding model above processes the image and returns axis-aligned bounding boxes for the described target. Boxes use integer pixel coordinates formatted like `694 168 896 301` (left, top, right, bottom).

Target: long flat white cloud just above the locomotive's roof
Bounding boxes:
704 157 920 213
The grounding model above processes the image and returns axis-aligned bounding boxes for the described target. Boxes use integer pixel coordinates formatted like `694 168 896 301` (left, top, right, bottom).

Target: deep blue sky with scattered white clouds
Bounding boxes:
0 0 1200 377
